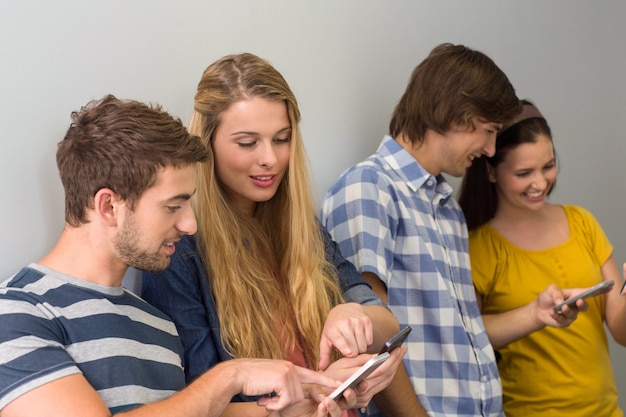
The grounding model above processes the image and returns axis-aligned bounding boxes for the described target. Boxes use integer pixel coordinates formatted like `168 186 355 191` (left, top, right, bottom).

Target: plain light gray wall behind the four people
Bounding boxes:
0 0 626 408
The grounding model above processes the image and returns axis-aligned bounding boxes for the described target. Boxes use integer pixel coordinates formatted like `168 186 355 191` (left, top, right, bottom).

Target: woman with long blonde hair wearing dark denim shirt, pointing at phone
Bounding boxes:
142 54 408 416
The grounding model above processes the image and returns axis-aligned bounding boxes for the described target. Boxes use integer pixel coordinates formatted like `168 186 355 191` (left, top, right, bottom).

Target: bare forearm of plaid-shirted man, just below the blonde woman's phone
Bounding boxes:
374 365 427 417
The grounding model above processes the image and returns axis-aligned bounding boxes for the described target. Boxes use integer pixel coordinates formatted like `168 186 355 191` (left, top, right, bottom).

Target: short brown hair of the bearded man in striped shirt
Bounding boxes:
57 95 207 226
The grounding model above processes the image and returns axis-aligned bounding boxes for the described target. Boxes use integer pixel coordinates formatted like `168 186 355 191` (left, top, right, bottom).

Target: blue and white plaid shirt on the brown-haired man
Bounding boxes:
321 136 504 417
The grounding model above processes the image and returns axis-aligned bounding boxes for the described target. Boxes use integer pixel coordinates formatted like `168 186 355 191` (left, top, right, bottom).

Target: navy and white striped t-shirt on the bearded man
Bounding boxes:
0 264 185 413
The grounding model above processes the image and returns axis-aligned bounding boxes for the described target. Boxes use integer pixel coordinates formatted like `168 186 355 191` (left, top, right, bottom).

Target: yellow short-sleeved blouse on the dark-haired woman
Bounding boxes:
469 206 624 417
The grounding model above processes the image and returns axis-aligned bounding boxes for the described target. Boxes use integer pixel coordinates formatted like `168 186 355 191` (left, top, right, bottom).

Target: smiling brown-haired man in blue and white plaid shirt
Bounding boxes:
321 44 521 417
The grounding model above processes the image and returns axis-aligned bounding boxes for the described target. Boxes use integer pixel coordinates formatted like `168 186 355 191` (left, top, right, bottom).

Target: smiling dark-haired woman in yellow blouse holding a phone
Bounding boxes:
459 101 626 417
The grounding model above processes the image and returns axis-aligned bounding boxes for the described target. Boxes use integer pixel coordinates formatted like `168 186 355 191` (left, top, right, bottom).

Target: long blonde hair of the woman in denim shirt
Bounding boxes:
189 53 343 366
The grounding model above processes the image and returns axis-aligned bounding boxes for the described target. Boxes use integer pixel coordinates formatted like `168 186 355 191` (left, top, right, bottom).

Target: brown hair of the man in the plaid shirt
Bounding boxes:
389 43 521 143
